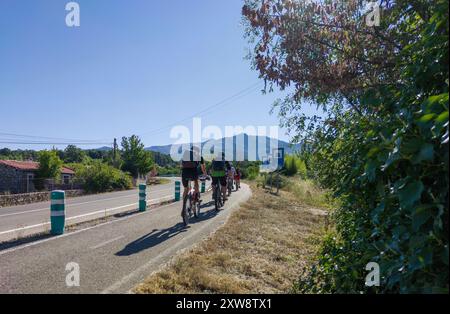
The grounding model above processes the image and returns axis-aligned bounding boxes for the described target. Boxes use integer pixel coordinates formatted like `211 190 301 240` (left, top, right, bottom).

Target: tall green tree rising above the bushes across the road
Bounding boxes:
121 135 153 178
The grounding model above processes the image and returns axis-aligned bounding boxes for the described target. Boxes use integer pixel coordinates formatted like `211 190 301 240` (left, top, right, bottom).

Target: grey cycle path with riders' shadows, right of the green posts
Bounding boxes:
0 184 251 293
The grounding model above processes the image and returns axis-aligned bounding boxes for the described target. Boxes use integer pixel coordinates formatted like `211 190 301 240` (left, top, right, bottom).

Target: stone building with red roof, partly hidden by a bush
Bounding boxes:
0 160 75 194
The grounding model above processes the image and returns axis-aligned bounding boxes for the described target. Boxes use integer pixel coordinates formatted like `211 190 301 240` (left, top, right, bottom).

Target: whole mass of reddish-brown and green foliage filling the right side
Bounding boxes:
242 0 449 293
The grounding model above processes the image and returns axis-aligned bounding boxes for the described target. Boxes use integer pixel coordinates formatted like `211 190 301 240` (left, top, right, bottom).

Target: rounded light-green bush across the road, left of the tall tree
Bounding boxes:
69 160 132 193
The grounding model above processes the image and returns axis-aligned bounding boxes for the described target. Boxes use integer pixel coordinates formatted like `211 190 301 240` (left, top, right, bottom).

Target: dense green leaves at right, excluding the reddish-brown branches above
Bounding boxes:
298 4 449 293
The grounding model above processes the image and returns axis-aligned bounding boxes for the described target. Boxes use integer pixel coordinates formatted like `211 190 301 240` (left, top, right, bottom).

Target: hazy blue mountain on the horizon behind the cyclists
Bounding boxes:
146 134 300 160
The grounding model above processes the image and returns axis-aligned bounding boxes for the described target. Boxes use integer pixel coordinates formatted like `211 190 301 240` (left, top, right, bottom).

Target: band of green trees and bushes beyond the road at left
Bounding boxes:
0 135 179 193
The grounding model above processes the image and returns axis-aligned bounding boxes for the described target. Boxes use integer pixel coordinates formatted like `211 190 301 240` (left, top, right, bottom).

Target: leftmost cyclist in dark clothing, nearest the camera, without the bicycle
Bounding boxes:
181 146 206 199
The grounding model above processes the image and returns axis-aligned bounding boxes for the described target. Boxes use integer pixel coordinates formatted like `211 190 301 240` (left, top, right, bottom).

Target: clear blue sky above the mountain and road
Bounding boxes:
0 0 316 149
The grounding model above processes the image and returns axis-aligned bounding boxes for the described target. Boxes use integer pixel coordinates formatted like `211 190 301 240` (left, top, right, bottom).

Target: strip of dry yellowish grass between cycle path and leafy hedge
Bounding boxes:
134 185 324 293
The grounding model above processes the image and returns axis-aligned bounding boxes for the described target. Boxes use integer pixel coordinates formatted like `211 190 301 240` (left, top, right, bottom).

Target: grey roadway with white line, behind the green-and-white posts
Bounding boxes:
0 178 183 241
